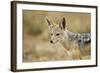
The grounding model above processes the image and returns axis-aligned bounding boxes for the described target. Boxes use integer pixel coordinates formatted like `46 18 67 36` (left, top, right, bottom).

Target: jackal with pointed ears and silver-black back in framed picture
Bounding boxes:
46 17 91 60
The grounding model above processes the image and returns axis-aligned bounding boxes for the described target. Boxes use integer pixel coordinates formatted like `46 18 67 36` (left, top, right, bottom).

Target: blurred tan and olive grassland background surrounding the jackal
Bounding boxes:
23 10 91 62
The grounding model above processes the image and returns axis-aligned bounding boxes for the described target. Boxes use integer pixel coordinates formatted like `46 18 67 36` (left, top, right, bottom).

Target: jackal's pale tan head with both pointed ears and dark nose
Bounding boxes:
46 17 66 43
